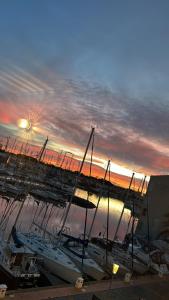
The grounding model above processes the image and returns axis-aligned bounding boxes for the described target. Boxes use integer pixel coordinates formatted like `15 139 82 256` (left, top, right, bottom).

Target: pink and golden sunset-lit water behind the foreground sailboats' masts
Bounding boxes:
0 189 130 239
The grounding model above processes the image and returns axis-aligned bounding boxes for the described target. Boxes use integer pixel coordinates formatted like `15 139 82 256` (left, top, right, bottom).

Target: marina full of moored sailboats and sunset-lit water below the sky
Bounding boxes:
0 128 169 299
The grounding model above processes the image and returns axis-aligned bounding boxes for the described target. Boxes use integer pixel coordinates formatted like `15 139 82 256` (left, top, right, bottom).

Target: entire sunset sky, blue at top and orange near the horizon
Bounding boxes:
0 0 169 185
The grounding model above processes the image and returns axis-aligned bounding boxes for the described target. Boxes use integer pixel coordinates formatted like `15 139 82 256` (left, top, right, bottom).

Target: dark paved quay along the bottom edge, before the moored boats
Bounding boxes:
5 275 169 300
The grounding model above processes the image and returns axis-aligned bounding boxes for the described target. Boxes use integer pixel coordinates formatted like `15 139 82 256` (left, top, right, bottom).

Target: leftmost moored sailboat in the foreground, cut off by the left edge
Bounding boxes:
0 137 50 288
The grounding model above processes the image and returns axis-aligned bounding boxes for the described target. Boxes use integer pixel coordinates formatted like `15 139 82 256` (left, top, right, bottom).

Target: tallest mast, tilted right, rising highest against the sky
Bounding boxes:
57 127 95 246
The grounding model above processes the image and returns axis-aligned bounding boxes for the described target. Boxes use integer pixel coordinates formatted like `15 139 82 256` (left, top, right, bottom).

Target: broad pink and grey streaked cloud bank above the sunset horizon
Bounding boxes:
0 66 169 178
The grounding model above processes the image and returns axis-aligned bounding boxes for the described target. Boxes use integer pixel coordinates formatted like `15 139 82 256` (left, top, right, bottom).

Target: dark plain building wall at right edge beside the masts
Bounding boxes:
136 175 169 239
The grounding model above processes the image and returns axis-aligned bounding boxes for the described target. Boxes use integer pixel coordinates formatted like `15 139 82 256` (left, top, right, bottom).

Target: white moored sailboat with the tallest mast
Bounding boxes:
17 128 105 282
